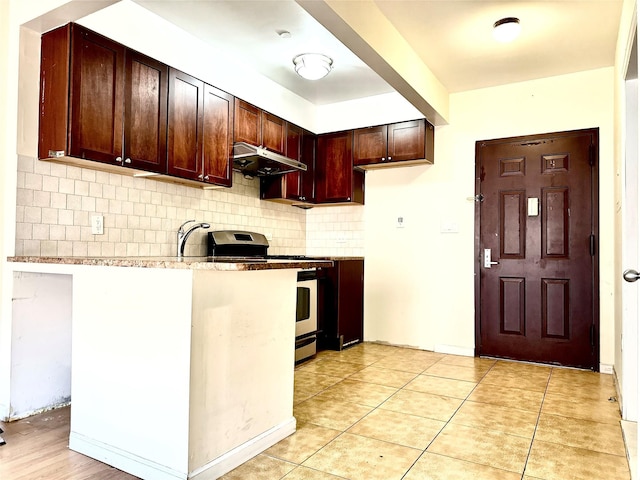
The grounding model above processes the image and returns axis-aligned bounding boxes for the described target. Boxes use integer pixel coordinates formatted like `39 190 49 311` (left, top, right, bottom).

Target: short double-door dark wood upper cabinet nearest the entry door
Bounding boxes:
353 119 433 167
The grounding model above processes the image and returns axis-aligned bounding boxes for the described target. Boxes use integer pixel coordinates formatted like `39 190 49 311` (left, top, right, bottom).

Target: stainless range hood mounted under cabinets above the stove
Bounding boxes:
233 142 307 177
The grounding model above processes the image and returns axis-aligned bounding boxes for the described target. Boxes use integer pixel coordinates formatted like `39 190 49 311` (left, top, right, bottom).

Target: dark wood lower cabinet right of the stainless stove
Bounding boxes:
318 259 364 350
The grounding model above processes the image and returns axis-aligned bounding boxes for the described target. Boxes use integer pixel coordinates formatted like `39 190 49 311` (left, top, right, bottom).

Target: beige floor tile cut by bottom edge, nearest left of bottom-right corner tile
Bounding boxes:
402 452 520 480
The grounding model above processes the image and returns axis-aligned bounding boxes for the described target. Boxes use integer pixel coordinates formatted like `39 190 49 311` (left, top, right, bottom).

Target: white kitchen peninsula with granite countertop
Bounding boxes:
9 257 332 480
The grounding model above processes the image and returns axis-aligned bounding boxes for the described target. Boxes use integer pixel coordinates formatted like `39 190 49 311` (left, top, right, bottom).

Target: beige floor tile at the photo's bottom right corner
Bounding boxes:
526 440 630 480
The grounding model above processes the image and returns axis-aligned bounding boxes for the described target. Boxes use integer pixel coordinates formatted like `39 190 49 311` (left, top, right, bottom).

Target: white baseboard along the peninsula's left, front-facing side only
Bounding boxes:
69 432 187 480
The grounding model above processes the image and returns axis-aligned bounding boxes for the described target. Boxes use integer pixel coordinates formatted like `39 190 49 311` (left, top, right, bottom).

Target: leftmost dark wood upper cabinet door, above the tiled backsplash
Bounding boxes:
69 25 125 163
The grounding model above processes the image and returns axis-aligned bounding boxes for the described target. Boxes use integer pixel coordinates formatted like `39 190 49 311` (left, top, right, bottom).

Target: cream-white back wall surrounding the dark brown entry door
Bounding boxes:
365 68 614 365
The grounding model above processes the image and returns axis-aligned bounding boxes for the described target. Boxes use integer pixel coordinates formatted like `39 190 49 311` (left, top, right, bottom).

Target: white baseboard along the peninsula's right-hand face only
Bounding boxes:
189 417 296 480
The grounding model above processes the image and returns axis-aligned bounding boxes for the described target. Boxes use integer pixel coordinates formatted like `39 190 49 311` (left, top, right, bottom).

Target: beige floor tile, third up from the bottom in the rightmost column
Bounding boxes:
542 393 621 425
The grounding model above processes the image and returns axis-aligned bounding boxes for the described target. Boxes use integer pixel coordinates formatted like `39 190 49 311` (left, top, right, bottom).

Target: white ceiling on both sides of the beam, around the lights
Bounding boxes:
134 0 622 105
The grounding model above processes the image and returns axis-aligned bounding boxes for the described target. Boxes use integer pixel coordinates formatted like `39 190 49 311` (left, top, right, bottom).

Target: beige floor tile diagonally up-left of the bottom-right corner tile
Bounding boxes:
451 401 538 440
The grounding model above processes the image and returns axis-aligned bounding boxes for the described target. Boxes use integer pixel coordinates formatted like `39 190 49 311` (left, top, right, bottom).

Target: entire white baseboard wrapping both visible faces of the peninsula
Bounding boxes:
69 417 296 480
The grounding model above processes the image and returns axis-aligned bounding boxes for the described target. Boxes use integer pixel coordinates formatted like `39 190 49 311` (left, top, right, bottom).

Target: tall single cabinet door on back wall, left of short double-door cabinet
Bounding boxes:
316 130 353 203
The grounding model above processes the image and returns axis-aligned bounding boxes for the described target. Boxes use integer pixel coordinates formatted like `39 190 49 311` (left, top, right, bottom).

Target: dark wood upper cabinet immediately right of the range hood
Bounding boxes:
260 123 316 203
